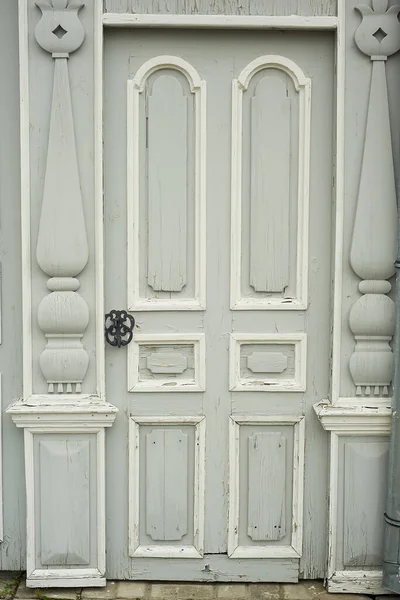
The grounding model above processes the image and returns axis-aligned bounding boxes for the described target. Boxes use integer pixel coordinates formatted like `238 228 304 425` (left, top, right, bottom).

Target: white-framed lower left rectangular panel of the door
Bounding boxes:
129 417 205 558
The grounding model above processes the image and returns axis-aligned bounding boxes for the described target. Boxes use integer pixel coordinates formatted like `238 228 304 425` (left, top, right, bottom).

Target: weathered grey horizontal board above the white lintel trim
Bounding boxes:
104 0 337 17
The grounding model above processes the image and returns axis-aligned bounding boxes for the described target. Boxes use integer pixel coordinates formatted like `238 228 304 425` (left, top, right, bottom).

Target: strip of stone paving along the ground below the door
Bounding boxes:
0 572 400 600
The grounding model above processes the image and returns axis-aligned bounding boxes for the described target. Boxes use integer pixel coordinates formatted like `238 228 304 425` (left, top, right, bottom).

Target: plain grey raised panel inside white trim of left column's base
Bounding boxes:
39 439 91 566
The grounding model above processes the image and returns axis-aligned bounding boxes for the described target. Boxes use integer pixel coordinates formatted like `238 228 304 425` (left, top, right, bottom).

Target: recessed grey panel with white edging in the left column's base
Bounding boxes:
34 432 99 573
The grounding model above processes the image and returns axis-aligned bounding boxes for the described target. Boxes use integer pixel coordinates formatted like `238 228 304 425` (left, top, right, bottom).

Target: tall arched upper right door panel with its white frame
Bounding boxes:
231 56 311 310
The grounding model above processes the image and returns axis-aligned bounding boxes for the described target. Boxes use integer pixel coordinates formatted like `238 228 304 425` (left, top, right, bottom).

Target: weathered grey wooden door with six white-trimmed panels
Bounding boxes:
104 30 333 581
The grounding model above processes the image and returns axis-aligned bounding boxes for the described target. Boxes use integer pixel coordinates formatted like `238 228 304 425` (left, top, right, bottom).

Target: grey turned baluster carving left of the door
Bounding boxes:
35 0 89 394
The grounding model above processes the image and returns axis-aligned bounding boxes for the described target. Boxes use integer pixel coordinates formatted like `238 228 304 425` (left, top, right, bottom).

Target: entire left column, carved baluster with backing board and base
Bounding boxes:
7 0 117 587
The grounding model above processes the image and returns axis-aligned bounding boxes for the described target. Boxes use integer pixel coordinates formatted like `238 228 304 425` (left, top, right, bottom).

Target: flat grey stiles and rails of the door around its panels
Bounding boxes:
104 28 334 581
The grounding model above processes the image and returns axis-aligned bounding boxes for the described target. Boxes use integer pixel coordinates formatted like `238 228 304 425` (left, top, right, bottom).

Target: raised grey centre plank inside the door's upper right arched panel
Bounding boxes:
250 76 290 292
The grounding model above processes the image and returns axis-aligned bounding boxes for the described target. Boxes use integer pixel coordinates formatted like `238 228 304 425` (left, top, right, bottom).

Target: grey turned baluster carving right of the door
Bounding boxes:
349 0 400 396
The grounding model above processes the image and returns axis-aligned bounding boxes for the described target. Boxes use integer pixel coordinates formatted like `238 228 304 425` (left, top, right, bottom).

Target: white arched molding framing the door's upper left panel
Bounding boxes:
127 55 207 311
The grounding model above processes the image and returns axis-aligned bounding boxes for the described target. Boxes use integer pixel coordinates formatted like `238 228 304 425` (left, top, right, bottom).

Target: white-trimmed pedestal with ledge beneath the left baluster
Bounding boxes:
7 397 117 587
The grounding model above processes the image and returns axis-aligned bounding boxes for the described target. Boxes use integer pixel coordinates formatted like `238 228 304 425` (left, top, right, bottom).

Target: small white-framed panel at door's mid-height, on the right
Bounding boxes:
229 333 307 392
